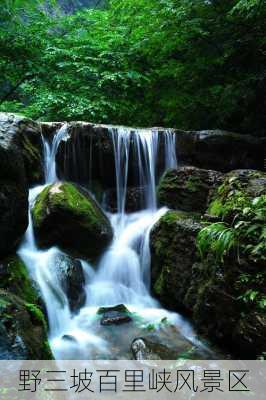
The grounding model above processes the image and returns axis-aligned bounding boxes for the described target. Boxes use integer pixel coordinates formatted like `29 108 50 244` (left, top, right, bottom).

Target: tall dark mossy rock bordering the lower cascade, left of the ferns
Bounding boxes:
150 211 201 308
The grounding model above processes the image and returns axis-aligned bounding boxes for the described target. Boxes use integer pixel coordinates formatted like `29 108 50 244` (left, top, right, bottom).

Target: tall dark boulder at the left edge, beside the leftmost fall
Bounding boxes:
0 113 43 258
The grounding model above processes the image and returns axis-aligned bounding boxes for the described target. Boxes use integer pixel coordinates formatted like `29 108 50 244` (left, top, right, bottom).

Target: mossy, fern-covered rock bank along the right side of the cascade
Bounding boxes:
151 167 266 358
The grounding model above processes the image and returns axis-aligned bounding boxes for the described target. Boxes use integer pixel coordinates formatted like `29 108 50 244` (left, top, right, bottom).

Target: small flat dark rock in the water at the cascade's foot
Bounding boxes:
97 304 132 325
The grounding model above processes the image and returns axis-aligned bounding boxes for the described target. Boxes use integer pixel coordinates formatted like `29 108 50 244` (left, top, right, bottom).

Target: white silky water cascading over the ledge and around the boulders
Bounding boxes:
19 125 216 359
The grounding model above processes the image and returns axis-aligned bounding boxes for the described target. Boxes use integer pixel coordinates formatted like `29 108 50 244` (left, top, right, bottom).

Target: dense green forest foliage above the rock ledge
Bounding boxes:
0 0 266 135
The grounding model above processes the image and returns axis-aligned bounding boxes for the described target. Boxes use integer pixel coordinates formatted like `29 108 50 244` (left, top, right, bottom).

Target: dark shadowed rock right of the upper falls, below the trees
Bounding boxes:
176 130 266 172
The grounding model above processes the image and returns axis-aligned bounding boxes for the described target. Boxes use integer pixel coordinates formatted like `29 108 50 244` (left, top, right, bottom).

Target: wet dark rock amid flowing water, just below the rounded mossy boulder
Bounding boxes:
55 254 86 311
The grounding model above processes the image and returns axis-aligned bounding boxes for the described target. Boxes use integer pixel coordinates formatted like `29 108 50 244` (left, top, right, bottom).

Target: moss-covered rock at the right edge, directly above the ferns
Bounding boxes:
207 170 266 222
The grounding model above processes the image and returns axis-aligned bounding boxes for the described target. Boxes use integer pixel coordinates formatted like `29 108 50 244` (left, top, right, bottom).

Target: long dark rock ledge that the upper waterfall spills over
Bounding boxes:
41 122 265 183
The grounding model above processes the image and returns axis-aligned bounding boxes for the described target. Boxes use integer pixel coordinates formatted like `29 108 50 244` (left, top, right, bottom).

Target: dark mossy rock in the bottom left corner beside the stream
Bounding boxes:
0 290 53 360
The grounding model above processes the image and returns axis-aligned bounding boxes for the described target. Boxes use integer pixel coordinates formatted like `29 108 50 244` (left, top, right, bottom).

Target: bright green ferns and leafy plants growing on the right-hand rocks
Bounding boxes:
197 195 266 311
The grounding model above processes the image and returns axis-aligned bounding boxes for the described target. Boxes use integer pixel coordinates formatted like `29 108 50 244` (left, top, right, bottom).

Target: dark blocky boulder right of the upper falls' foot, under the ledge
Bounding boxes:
157 167 222 213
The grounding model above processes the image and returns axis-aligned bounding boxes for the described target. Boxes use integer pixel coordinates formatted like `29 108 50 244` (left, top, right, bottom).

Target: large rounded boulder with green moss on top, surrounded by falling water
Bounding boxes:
32 182 112 261
